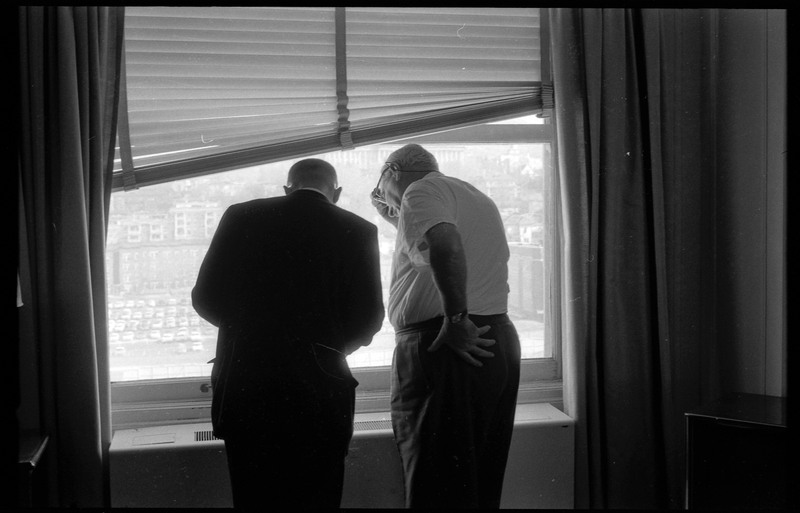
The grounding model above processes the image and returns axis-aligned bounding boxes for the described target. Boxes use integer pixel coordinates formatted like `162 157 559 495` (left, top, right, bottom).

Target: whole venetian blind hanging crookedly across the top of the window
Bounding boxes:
113 6 548 189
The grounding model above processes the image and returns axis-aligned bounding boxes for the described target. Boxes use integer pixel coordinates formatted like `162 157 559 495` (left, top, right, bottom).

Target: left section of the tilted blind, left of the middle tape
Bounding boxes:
117 7 336 179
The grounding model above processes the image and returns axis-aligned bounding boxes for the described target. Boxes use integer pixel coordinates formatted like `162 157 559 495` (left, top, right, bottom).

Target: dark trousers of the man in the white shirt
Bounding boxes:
392 315 520 508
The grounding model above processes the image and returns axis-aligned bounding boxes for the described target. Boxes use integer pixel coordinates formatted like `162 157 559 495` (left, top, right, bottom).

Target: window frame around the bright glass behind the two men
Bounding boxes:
111 119 562 429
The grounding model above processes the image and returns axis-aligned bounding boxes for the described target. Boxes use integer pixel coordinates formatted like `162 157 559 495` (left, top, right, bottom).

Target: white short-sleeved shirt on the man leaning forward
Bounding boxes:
387 172 509 329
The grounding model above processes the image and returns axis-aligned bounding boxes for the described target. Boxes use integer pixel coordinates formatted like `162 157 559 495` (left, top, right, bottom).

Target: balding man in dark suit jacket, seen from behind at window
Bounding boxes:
192 159 384 507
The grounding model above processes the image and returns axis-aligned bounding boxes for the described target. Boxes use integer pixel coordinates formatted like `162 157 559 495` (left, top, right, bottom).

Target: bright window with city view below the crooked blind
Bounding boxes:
107 119 560 424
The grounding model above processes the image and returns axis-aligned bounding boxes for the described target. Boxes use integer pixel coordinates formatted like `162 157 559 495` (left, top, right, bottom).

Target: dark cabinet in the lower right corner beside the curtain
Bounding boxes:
686 394 789 510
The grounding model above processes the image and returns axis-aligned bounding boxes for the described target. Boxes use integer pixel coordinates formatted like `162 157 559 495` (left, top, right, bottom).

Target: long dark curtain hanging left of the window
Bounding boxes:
18 6 123 507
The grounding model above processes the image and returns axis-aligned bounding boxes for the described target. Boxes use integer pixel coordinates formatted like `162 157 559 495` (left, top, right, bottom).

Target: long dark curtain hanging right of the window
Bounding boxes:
549 9 708 509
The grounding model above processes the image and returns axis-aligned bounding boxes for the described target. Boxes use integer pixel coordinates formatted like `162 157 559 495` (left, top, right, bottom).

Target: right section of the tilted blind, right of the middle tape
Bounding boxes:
347 8 541 143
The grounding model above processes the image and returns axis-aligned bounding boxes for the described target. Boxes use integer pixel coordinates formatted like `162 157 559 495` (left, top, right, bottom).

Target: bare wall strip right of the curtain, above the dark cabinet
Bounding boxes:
715 9 786 396
